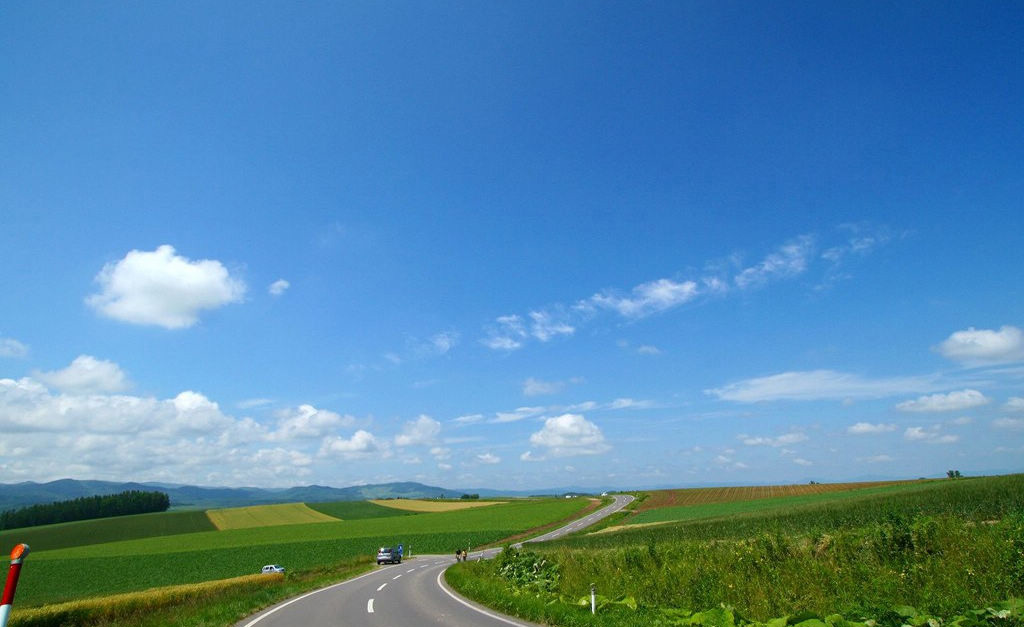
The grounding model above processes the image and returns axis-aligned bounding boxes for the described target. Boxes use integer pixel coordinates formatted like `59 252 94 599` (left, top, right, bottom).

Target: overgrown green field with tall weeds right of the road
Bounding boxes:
450 475 1024 627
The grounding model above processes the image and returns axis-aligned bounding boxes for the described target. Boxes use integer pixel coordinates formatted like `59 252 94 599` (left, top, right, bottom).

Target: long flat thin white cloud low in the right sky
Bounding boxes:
705 370 935 403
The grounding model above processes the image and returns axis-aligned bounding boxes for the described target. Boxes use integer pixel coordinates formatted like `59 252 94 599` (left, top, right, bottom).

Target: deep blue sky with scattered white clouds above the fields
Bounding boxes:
0 2 1024 490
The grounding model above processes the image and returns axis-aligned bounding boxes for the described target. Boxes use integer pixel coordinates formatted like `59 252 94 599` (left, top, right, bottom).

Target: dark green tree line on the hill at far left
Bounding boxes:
0 490 171 530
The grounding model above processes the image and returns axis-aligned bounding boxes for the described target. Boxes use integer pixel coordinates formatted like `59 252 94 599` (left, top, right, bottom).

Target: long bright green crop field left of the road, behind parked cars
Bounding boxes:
17 499 588 607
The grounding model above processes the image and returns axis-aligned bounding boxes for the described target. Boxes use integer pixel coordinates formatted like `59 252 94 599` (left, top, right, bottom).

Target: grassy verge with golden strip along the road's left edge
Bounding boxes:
9 556 375 627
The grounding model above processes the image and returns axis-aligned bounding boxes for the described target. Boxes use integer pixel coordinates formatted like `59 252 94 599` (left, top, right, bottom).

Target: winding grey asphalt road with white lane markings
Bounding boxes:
236 495 633 627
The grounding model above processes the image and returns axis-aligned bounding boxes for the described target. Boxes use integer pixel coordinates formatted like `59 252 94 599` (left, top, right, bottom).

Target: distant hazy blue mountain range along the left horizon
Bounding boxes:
0 478 588 510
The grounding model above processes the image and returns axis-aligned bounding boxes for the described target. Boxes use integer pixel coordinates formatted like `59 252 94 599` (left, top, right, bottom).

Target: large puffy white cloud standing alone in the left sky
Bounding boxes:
86 245 246 329
